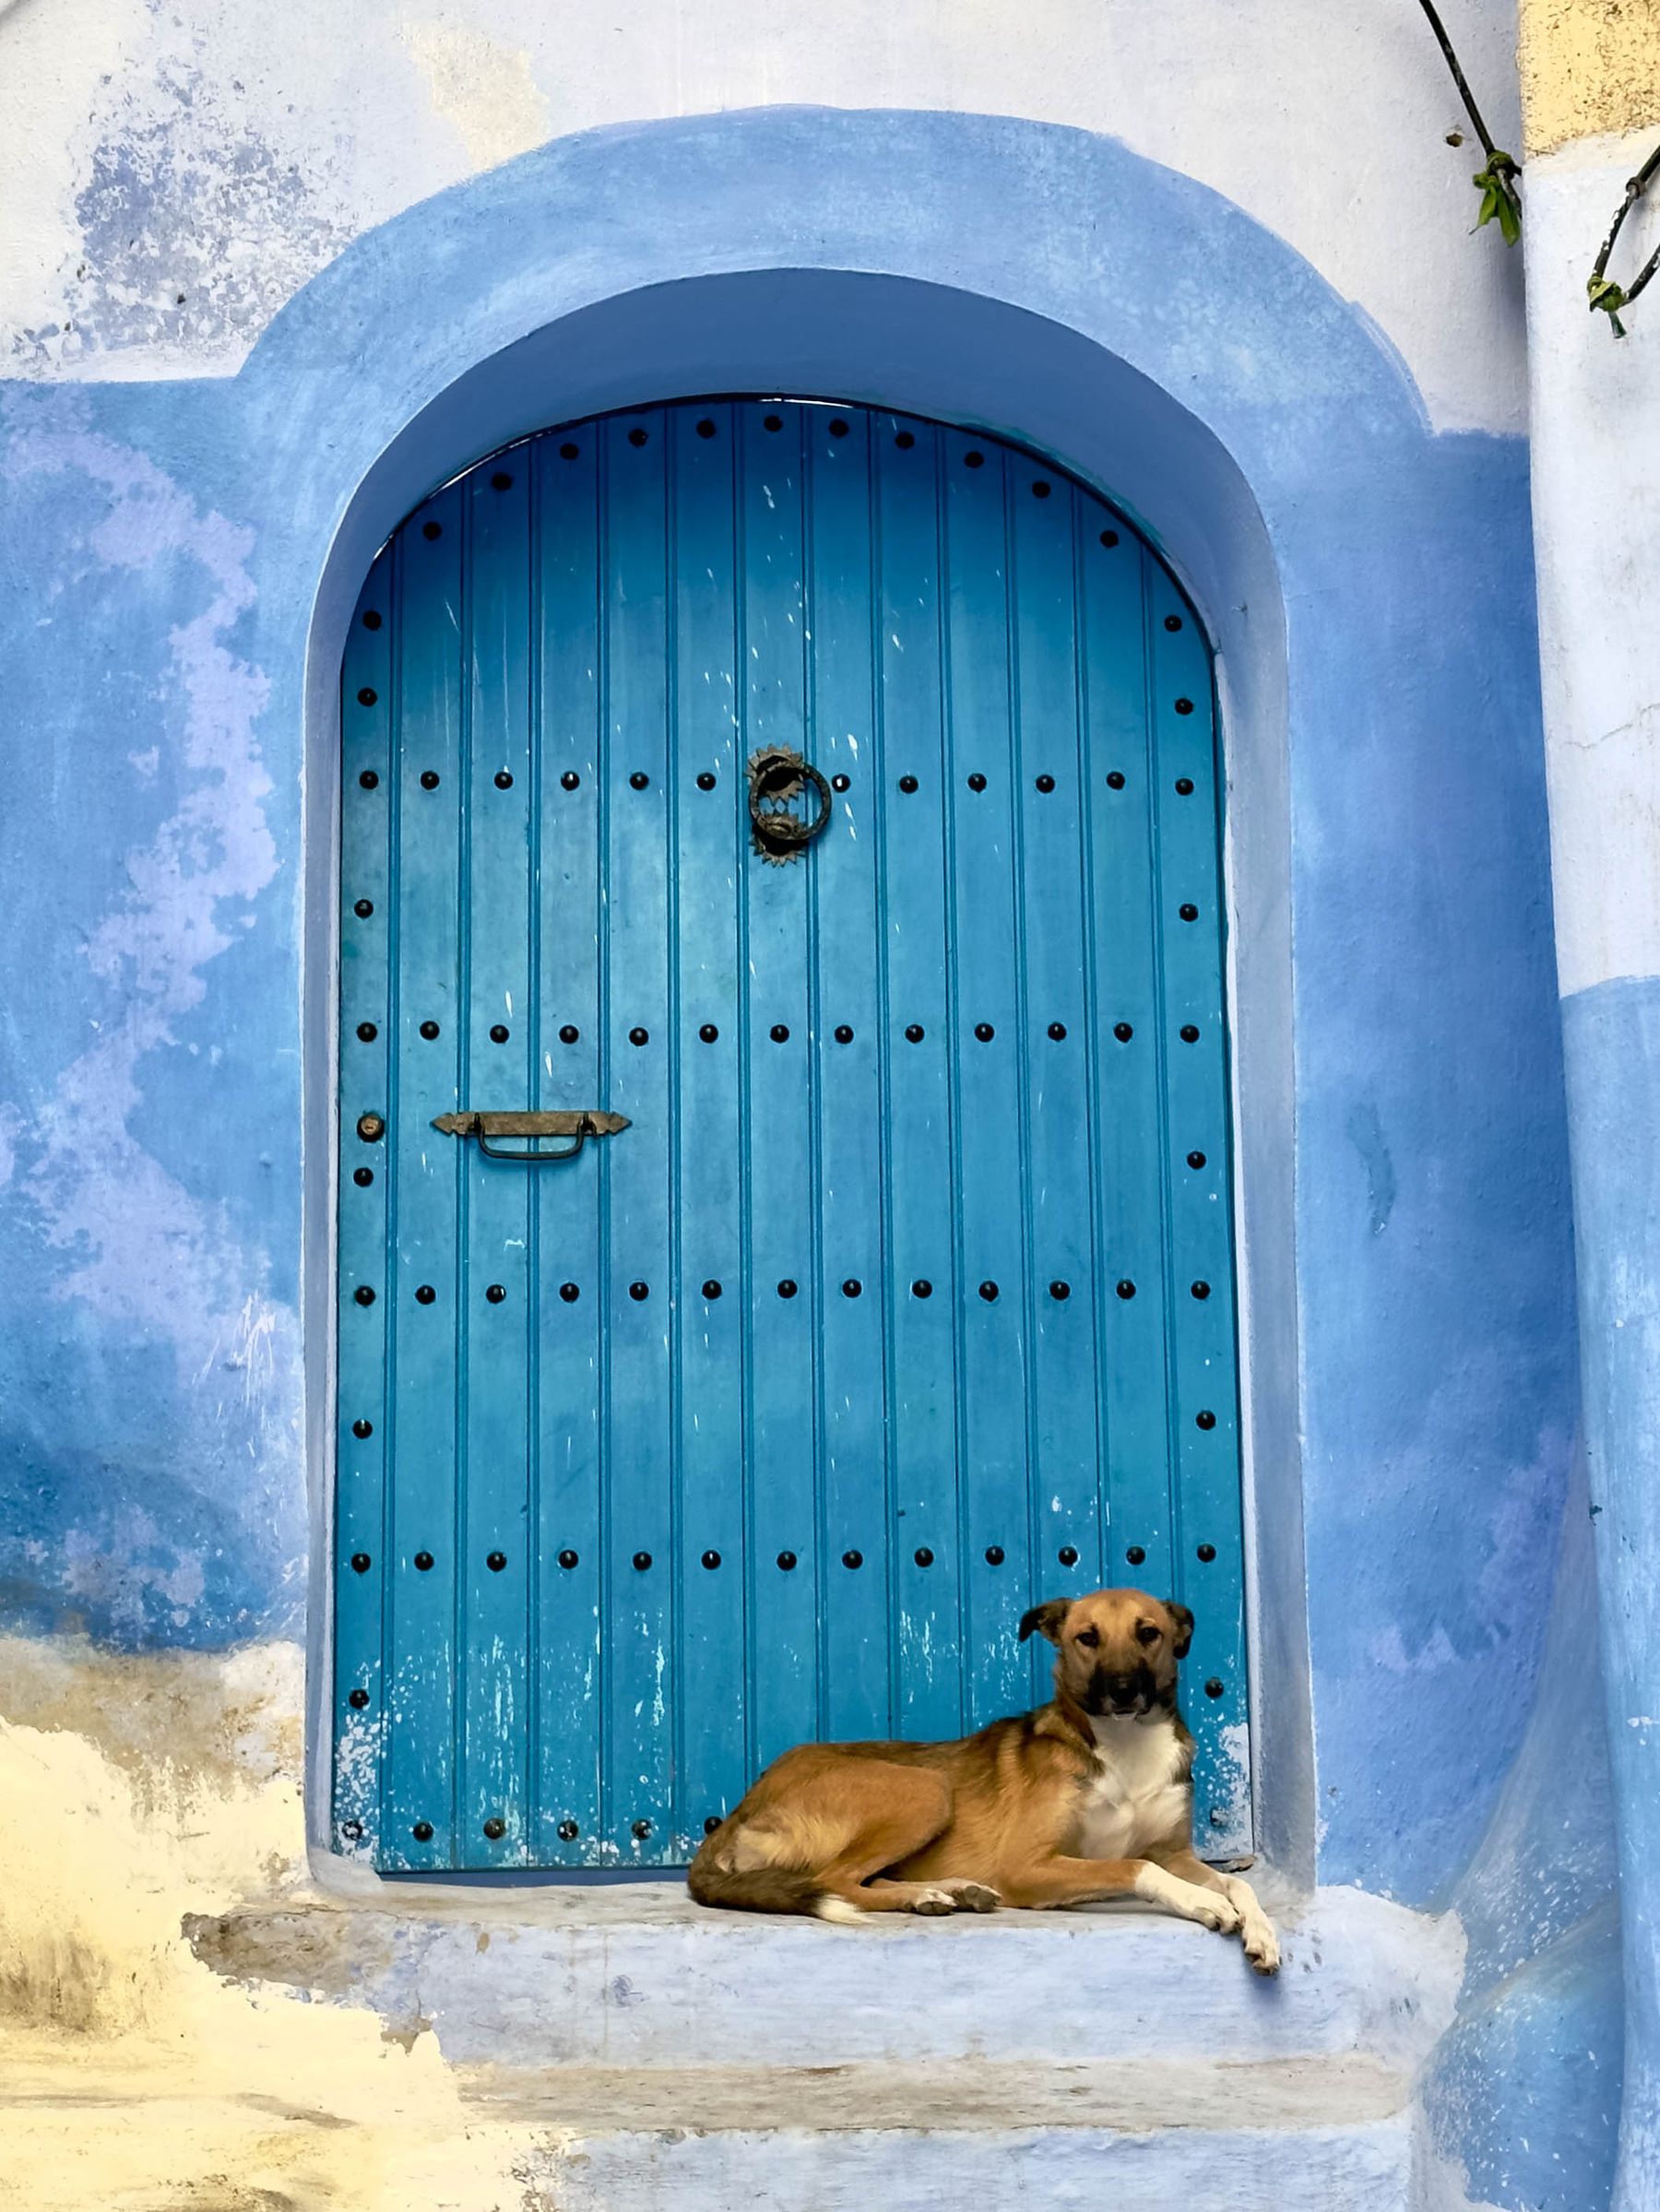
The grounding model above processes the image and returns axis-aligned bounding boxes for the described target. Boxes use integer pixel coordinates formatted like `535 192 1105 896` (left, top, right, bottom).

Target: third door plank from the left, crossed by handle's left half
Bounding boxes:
460 455 528 1867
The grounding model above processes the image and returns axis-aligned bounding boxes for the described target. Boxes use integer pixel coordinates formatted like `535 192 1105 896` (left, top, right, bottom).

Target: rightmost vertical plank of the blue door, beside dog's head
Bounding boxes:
1149 571 1251 1853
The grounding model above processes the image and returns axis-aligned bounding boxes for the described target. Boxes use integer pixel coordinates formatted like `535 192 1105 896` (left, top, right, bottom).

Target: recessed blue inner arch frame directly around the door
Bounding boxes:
303 270 1315 1889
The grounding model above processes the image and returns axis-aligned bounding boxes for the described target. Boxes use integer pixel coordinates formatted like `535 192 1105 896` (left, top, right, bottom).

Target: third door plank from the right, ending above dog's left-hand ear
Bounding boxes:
1007 454 1107 1674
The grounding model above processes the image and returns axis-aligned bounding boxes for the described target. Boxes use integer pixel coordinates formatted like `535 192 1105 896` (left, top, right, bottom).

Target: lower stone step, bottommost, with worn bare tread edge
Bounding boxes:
463 2052 1412 2212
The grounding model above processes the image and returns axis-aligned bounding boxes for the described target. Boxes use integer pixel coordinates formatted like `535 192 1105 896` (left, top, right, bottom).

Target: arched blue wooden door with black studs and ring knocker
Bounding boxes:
334 400 1251 1869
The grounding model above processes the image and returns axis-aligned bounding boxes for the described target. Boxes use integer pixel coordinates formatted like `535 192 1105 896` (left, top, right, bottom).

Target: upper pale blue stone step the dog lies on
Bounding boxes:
186 1885 1461 2075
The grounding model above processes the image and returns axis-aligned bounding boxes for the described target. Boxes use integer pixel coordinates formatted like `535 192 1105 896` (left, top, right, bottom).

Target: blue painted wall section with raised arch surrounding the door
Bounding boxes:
0 111 1607 2203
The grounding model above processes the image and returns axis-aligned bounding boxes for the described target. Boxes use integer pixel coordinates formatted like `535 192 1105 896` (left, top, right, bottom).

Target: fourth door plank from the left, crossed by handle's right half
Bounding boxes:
533 425 606 1867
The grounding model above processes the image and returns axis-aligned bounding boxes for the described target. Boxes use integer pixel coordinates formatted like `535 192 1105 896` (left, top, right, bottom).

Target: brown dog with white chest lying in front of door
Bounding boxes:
686 1591 1279 1973
